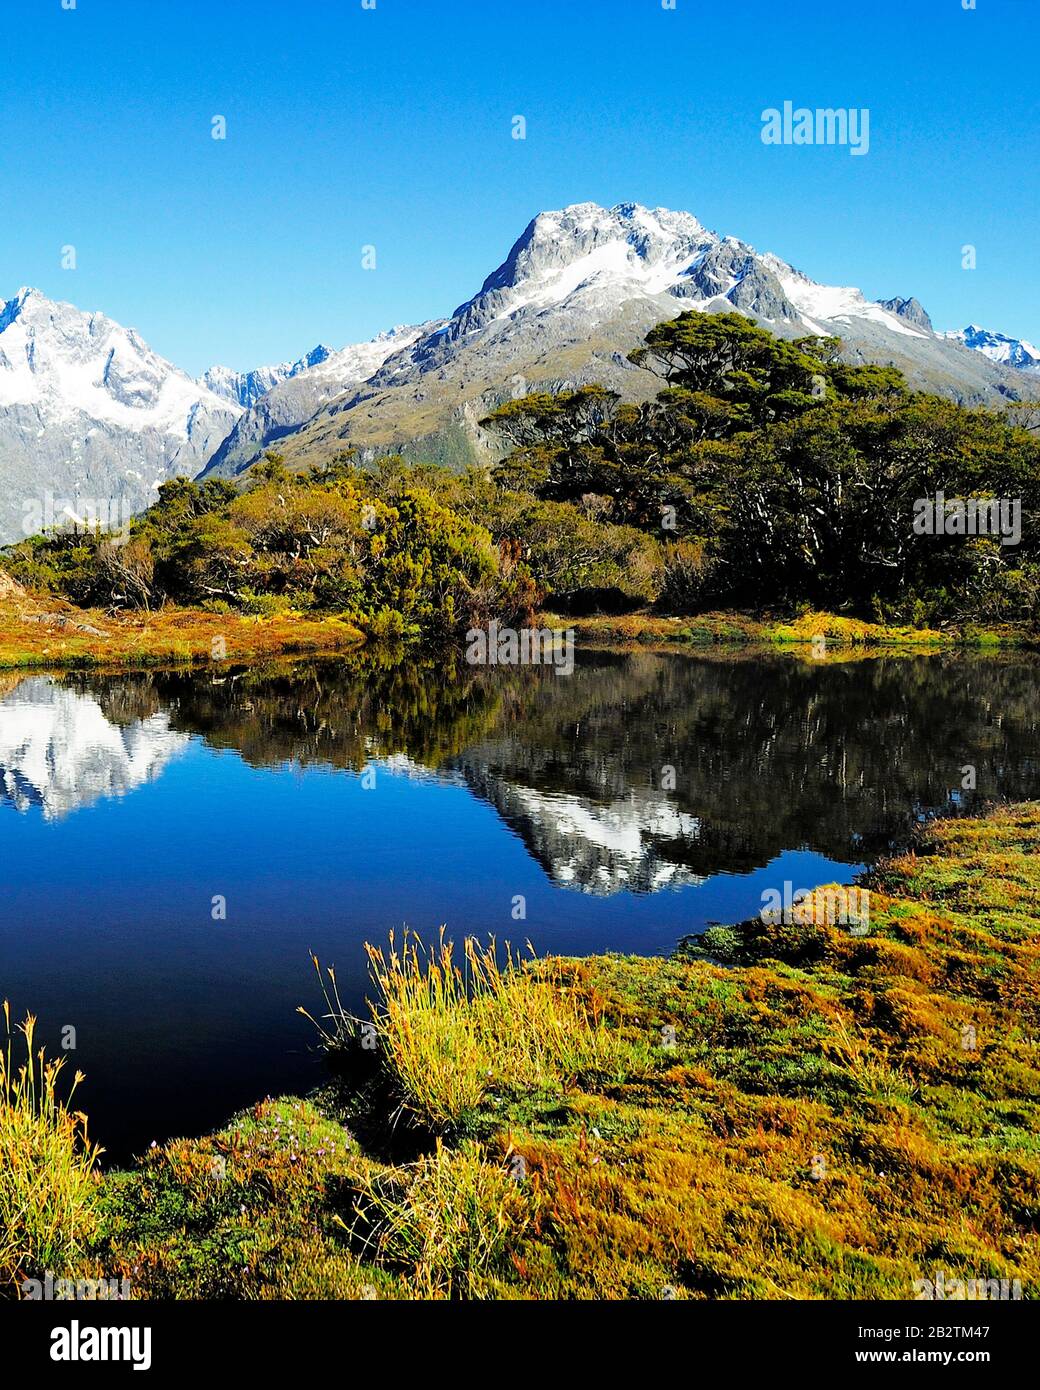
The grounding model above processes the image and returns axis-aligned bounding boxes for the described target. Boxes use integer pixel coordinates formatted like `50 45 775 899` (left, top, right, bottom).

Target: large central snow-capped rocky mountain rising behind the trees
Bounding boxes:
210 203 1033 475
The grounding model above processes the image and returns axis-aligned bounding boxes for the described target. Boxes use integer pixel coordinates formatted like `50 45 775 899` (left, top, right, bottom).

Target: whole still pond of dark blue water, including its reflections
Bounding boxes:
0 653 1040 1158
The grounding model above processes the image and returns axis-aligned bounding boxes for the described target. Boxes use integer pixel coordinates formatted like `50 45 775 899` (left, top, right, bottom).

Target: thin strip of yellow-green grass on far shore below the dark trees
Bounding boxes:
541 612 1040 652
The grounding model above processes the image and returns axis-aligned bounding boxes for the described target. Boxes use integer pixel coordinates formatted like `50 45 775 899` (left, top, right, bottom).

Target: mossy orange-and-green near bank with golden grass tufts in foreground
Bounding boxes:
8 803 1040 1298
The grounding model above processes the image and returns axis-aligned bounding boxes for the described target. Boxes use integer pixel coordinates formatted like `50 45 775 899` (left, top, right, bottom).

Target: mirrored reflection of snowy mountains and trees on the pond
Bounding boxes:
0 653 1040 894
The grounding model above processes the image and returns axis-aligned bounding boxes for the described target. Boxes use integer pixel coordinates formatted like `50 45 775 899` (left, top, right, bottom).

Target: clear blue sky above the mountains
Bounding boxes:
0 0 1040 373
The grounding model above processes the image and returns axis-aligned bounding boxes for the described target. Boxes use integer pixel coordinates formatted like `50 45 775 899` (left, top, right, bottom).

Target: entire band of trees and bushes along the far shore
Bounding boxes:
4 313 1040 639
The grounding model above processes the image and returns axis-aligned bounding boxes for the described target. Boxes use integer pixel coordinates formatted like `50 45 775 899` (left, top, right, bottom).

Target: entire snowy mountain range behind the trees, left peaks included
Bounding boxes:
0 203 1040 541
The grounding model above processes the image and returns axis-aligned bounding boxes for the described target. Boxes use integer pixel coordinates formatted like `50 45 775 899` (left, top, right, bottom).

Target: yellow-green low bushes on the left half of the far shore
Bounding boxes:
7 456 535 638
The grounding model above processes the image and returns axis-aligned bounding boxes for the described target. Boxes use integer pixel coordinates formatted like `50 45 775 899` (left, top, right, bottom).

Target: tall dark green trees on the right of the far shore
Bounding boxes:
484 313 1040 623
